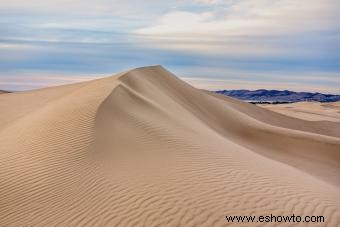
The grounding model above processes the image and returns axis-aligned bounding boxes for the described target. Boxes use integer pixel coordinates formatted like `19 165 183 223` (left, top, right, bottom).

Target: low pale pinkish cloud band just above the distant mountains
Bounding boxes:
180 67 340 94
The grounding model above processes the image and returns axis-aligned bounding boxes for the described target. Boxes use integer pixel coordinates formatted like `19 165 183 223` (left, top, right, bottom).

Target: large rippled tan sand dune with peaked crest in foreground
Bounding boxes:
0 67 340 226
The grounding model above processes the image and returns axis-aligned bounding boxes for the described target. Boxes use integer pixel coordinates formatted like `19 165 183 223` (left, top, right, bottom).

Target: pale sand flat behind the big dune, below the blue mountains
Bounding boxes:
259 102 340 122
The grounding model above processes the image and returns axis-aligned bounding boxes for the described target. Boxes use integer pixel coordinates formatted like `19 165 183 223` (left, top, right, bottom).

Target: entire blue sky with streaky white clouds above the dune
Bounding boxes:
0 0 340 93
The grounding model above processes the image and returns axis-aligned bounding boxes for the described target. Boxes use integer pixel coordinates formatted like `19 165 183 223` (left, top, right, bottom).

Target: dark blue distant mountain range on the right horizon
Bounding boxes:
215 89 340 104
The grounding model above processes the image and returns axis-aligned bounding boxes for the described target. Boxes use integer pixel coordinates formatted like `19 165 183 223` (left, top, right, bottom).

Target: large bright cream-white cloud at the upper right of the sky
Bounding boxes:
135 0 340 56
